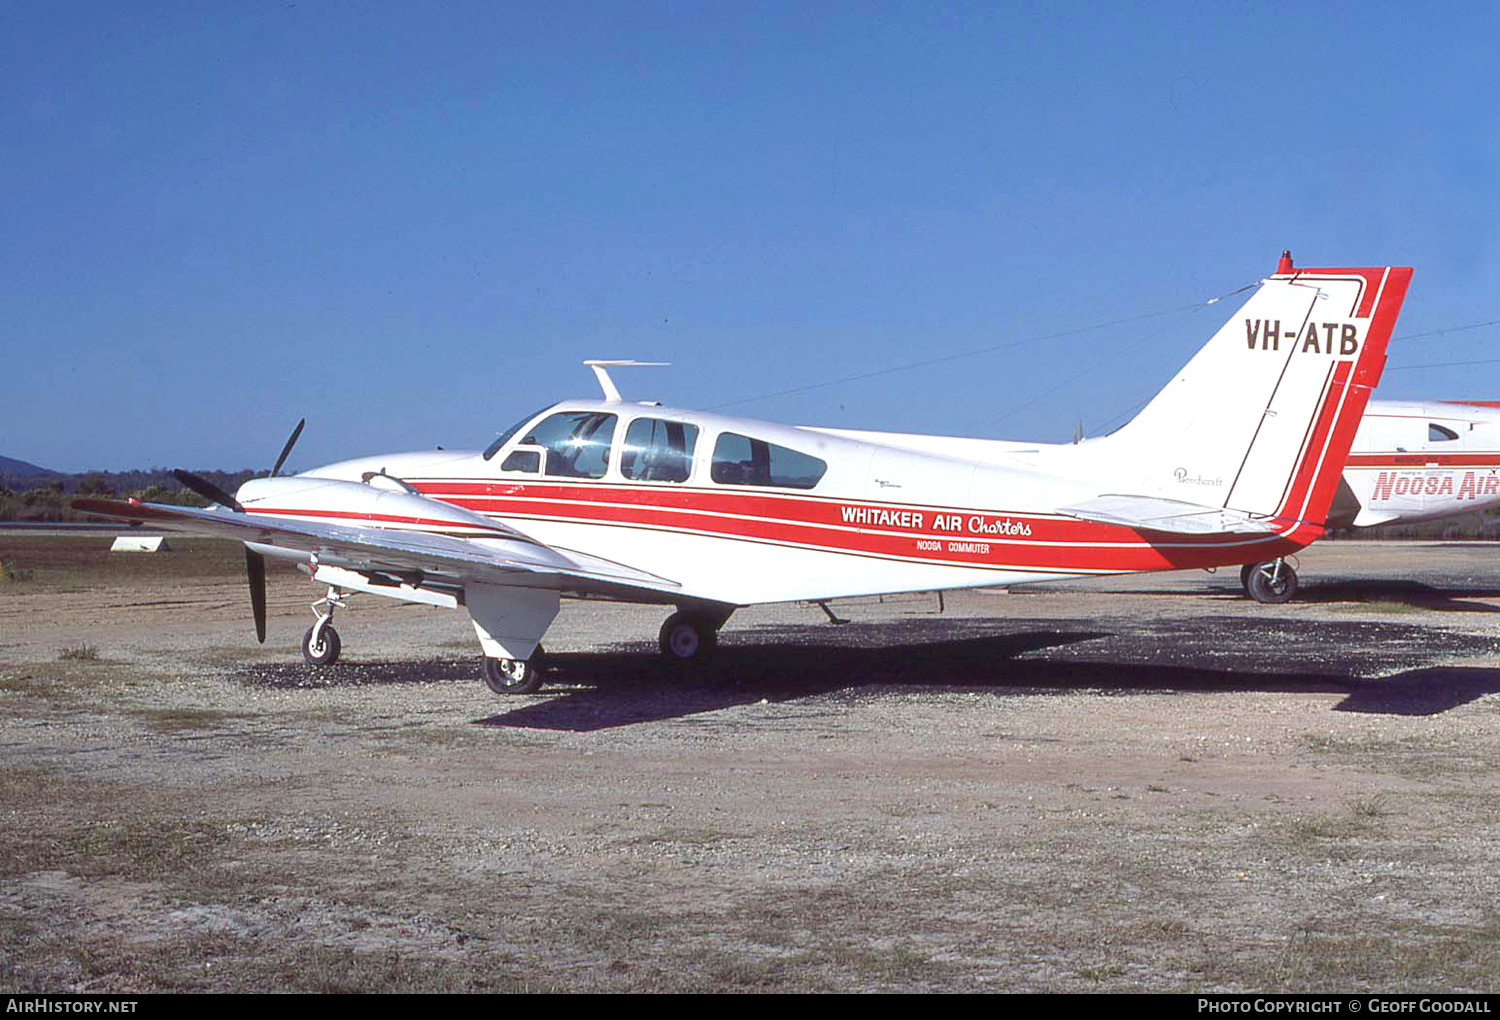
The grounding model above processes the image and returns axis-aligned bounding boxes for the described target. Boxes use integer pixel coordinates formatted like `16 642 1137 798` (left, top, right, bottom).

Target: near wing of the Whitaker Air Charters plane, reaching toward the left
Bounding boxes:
74 500 678 597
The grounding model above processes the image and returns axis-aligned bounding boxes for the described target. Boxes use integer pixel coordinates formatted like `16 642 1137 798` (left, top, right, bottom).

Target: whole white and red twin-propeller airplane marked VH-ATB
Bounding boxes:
75 255 1412 693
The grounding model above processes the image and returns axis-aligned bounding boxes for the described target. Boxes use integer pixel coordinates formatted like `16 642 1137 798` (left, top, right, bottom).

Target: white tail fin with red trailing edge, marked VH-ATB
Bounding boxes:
1101 255 1412 525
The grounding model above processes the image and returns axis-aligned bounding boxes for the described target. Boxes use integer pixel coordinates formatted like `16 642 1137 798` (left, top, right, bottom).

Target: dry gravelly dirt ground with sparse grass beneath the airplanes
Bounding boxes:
0 534 1500 992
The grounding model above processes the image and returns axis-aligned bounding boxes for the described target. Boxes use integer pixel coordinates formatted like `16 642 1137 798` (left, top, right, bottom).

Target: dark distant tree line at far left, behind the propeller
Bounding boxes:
0 468 266 521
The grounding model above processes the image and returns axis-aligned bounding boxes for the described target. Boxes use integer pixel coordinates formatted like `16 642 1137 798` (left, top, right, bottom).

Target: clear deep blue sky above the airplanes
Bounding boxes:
0 0 1500 470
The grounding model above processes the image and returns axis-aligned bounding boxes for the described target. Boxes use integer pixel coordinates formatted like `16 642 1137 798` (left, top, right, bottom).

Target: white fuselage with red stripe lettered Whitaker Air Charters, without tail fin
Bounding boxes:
267 401 1322 605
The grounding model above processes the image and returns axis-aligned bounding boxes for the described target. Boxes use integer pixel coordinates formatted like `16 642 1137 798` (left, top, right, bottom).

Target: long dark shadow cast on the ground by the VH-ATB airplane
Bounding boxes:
476 621 1500 732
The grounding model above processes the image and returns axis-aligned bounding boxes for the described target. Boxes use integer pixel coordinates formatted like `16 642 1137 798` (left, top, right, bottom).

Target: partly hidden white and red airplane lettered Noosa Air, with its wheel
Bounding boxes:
1241 401 1500 603
